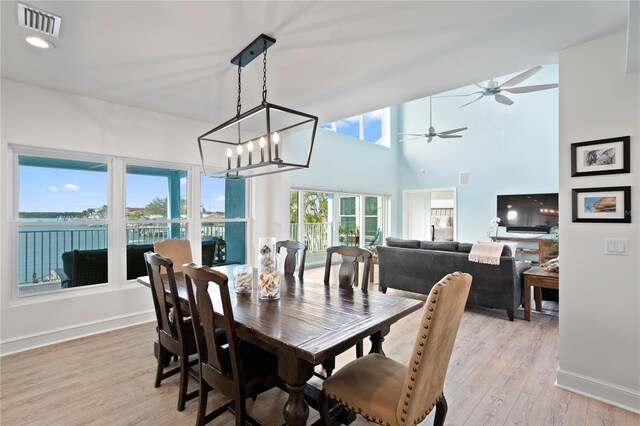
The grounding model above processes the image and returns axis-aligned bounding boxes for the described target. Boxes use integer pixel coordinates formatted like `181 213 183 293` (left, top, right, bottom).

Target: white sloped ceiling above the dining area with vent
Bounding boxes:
0 1 629 122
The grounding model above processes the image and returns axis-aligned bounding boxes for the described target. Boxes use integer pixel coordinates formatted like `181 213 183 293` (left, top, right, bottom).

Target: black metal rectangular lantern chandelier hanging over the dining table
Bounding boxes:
198 34 318 179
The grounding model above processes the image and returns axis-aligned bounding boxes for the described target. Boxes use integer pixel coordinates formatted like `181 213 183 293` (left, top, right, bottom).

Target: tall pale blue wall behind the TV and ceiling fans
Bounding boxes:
396 64 558 242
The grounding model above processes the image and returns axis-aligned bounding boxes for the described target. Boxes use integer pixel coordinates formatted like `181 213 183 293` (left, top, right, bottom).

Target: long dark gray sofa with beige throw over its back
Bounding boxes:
377 238 531 321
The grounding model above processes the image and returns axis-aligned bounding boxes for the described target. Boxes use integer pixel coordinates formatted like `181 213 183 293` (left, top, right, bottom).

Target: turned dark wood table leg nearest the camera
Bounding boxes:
278 352 313 426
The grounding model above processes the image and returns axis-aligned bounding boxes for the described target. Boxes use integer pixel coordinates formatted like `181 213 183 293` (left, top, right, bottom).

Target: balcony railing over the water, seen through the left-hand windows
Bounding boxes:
18 222 225 285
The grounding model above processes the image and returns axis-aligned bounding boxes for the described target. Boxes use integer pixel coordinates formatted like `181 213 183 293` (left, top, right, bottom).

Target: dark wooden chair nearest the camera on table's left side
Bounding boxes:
184 263 281 425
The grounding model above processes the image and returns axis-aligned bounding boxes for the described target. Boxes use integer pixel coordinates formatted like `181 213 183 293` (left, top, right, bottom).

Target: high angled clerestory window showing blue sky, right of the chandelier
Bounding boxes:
320 108 389 146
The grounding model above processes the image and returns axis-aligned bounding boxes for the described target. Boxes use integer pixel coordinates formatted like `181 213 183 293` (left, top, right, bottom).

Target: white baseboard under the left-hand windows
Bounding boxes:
0 310 156 356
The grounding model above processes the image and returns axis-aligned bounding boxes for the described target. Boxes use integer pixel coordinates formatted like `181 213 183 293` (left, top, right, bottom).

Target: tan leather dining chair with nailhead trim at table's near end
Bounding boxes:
320 272 471 426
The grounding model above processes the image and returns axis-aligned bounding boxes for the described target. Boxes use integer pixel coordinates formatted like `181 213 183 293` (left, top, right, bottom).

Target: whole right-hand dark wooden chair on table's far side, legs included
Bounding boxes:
316 246 373 379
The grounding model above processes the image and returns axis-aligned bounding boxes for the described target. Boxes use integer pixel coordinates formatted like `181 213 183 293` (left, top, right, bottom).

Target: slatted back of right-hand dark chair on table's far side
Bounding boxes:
324 246 373 293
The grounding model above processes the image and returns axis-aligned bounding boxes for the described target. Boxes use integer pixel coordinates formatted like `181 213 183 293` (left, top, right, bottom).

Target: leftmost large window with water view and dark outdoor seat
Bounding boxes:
16 155 109 296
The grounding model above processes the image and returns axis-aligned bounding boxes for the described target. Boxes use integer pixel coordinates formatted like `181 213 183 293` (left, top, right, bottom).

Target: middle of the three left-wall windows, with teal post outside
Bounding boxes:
125 164 188 280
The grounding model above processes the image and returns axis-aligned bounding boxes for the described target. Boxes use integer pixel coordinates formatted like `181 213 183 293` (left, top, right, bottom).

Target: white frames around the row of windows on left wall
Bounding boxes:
10 144 251 306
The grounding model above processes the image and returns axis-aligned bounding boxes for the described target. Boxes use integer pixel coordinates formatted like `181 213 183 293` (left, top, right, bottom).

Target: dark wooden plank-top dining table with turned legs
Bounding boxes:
138 265 422 425
